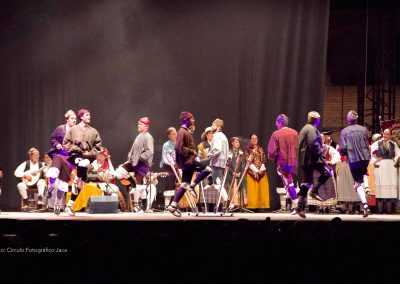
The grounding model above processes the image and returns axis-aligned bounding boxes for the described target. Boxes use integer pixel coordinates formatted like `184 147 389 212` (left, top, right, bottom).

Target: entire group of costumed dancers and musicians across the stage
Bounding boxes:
10 109 400 218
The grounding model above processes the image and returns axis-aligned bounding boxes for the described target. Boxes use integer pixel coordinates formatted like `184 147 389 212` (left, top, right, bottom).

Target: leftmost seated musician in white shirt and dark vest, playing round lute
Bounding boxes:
14 147 46 209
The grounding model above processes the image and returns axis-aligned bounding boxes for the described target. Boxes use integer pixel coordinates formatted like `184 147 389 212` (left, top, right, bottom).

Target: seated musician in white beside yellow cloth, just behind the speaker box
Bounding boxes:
88 148 119 196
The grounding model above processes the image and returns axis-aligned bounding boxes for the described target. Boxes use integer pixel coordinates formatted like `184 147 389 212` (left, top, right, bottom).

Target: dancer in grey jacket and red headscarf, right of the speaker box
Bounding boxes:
116 117 154 213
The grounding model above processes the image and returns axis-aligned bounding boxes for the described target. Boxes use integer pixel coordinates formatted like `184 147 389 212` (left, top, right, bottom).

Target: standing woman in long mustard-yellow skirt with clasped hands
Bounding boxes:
246 134 270 209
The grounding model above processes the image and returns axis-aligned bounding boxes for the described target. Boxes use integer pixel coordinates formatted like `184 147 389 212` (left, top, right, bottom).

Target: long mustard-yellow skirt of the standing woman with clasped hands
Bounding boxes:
246 175 270 209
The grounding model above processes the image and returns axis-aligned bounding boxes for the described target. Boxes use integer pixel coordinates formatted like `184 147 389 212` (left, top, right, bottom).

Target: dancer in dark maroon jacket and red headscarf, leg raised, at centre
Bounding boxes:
166 111 211 217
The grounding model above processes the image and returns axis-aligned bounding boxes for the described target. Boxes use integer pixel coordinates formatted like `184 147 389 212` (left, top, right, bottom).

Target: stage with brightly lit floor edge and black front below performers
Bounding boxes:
0 212 400 283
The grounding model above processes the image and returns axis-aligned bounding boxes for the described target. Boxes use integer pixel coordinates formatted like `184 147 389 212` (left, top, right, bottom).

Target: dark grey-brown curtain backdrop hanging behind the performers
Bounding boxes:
0 0 329 210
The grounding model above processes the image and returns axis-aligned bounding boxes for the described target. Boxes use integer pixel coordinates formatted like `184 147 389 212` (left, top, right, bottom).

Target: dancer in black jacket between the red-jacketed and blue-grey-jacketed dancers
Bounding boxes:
295 111 331 218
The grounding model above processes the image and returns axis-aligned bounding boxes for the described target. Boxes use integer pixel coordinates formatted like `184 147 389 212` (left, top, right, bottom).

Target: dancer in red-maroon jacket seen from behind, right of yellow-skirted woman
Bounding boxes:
268 114 298 213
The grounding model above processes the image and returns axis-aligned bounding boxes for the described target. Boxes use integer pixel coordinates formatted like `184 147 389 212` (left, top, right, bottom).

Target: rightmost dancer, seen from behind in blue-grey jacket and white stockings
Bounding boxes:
339 110 371 217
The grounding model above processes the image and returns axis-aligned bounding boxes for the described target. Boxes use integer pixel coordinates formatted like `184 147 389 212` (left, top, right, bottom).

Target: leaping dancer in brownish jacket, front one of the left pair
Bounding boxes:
63 109 101 216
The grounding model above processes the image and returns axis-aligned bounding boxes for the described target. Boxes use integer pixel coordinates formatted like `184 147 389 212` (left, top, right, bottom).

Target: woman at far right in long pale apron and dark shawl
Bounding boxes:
371 129 400 214
